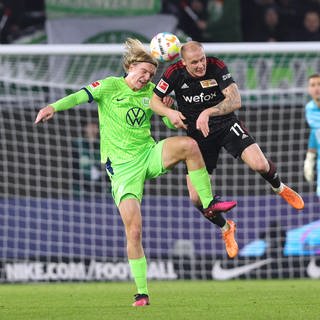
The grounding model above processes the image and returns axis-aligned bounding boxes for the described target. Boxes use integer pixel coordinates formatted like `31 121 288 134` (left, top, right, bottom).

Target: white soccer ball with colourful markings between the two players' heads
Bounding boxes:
150 32 180 62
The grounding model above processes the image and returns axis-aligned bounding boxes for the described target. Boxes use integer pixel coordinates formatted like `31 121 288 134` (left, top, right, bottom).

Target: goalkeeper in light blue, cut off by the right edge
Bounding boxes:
304 74 320 196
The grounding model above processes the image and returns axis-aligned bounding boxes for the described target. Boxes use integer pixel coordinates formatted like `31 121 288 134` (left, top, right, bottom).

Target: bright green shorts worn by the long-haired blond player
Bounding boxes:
106 140 169 206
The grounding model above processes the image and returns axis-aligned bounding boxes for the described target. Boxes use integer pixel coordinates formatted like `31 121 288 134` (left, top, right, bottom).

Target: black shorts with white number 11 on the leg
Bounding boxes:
193 118 256 174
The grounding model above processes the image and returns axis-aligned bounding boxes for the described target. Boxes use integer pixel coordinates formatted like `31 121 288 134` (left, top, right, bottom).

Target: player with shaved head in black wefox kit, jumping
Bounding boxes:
150 41 304 212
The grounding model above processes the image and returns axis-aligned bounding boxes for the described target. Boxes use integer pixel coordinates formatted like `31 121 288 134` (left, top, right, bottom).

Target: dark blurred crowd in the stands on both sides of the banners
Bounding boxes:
0 0 320 43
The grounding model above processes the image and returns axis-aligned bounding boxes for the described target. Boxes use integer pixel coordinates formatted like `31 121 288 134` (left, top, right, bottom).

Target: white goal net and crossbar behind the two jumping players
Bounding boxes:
0 43 320 281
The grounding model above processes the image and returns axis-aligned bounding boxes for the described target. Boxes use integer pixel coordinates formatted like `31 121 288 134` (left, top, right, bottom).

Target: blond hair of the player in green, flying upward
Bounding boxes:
122 38 158 72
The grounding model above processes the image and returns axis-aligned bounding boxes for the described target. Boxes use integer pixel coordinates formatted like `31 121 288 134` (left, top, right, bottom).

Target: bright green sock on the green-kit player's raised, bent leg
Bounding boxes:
188 167 213 208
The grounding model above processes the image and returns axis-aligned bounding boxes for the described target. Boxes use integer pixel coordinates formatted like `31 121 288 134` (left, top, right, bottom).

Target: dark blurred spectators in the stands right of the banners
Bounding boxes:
163 0 320 42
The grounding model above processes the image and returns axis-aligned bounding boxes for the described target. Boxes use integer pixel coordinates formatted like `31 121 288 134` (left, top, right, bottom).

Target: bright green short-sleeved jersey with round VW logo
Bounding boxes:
85 77 155 164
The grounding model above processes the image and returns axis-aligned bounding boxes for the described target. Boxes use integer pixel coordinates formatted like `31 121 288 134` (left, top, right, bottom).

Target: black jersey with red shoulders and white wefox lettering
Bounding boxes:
154 57 235 136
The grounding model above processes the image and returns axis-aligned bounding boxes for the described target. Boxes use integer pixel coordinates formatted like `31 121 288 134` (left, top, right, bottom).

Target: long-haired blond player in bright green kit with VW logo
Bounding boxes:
35 39 238 306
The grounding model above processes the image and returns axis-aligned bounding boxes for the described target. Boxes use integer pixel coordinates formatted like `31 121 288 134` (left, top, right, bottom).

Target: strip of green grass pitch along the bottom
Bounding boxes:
0 280 320 320
